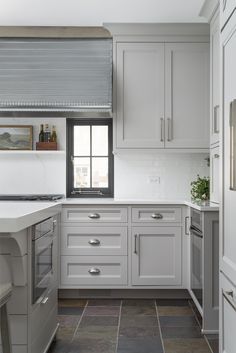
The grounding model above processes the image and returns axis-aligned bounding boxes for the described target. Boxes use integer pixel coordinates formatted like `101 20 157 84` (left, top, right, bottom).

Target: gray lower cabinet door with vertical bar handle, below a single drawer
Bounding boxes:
132 226 182 286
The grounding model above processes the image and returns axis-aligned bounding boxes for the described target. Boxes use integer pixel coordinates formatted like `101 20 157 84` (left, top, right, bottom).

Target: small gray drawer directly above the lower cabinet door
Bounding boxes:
132 207 181 223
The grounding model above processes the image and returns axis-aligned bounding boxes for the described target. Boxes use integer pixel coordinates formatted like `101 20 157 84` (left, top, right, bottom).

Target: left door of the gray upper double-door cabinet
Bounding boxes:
116 43 164 148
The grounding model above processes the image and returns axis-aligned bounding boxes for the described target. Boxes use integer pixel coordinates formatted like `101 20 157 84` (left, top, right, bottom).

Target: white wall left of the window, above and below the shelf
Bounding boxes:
0 117 66 194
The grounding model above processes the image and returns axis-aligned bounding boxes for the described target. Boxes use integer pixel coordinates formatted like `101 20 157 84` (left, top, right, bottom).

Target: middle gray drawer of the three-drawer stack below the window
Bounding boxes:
61 226 127 255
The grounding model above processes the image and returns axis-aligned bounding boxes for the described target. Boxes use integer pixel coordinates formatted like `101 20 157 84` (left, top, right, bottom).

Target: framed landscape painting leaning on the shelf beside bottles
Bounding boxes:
0 125 33 150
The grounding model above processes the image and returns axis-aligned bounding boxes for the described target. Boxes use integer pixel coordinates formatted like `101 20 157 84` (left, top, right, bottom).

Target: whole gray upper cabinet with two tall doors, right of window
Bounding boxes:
114 26 209 149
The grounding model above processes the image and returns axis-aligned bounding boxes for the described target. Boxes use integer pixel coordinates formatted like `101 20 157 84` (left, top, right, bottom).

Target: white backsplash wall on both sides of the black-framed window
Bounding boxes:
0 117 209 200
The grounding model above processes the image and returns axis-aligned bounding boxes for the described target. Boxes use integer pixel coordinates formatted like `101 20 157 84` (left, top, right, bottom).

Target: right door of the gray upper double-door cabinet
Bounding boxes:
165 43 209 148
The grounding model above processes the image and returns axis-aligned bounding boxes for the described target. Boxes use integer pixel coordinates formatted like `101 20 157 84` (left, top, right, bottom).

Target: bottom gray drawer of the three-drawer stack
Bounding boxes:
61 256 127 286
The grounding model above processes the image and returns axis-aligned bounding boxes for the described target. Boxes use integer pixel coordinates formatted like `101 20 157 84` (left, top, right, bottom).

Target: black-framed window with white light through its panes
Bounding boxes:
67 118 114 197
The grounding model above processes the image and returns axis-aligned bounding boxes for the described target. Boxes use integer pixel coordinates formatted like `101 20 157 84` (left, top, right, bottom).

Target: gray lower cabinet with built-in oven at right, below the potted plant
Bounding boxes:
189 208 219 334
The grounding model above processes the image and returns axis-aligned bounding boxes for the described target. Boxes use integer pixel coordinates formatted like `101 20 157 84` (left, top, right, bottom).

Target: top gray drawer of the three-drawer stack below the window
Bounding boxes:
62 207 128 223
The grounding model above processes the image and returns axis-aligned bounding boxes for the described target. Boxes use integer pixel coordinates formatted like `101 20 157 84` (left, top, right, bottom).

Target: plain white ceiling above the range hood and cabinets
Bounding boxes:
0 0 205 26
